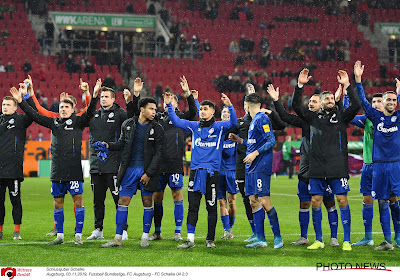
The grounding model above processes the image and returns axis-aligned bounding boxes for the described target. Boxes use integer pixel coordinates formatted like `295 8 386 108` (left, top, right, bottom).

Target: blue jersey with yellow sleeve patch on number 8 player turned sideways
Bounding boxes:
246 112 275 175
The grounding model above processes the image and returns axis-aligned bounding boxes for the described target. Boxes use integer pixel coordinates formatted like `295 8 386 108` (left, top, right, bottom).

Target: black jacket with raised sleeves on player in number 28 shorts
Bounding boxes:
20 97 98 182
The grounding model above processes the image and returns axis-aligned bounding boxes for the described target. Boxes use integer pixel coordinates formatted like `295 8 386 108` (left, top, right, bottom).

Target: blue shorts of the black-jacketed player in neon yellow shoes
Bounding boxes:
308 178 350 196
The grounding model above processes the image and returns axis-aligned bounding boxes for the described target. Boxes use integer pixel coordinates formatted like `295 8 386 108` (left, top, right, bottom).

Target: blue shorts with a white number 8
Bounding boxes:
244 172 271 197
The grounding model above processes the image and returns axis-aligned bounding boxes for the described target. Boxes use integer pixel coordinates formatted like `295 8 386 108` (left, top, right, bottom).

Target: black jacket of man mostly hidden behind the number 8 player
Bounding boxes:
229 111 286 180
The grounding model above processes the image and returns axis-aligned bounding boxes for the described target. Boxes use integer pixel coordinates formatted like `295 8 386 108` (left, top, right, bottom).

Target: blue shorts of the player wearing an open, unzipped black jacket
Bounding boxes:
119 167 153 197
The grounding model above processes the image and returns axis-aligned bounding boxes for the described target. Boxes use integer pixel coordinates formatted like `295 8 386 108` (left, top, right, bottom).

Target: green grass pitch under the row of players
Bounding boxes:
0 176 400 267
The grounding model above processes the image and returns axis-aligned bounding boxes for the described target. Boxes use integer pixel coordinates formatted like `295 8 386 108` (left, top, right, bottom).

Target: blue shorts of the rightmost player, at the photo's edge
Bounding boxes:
372 161 400 199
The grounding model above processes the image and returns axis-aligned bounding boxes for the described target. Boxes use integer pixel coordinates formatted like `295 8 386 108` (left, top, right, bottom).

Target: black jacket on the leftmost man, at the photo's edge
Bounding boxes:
0 102 34 181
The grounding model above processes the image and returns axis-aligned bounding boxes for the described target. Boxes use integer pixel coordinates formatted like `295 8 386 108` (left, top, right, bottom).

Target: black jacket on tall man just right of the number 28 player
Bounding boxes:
89 98 137 174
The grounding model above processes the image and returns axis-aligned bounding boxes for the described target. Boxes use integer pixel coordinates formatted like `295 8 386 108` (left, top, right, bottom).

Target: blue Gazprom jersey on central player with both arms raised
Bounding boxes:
167 104 237 171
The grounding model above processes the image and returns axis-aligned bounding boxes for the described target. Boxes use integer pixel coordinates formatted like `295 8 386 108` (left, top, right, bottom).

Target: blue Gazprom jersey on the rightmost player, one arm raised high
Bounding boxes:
357 83 400 162
